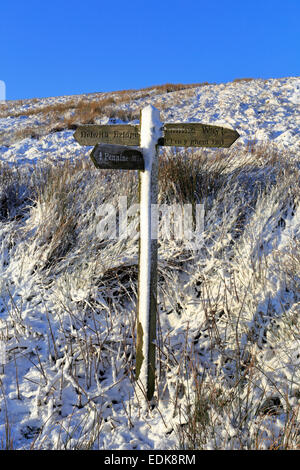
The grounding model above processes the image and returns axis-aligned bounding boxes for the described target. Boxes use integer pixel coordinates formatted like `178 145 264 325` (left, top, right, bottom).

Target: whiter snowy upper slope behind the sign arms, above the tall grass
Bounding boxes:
0 77 300 164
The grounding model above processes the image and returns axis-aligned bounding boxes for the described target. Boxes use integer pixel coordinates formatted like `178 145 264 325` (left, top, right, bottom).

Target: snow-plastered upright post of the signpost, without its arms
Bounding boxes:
136 105 162 400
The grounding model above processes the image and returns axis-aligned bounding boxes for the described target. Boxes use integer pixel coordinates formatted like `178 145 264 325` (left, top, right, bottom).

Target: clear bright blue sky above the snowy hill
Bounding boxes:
0 0 300 99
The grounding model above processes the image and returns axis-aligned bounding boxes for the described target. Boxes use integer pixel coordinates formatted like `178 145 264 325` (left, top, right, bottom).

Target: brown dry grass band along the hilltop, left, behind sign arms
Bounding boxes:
0 82 214 145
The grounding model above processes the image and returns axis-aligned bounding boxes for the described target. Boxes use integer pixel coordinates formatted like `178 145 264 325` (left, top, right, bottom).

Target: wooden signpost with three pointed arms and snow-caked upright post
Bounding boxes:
74 105 239 400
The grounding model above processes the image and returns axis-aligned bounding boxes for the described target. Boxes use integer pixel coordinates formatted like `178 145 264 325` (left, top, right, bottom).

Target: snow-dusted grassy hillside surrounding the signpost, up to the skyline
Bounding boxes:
0 77 300 449
